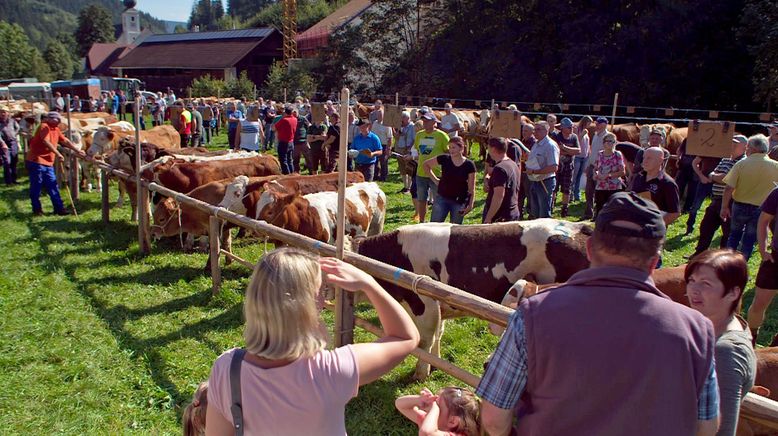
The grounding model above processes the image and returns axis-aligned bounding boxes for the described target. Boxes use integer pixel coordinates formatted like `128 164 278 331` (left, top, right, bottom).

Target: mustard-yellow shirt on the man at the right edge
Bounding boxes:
724 153 778 206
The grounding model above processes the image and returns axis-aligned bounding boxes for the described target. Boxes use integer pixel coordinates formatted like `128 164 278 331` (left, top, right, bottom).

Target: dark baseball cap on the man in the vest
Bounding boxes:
595 192 667 239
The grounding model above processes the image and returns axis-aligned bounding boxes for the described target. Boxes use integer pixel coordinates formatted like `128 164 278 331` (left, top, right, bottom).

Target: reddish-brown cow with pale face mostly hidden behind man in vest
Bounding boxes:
489 265 689 336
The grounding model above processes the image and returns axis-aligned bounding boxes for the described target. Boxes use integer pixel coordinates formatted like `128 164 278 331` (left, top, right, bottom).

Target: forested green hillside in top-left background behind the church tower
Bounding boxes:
0 0 165 51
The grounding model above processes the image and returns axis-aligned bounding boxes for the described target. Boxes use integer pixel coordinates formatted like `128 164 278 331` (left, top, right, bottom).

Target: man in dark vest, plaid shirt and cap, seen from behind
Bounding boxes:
476 192 719 436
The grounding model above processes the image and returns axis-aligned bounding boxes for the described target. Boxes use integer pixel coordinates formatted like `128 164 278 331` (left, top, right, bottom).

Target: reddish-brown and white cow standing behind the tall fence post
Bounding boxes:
259 182 386 244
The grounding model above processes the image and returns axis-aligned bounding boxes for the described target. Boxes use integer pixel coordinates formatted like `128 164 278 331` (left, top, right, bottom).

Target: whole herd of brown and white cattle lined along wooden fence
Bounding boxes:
30 111 778 426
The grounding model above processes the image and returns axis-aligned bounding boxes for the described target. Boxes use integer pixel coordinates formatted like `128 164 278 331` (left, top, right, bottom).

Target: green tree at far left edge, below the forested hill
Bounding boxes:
0 21 51 80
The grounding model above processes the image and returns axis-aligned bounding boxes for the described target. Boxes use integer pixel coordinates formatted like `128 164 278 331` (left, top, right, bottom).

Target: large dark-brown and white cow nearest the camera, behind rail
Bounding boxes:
353 218 593 380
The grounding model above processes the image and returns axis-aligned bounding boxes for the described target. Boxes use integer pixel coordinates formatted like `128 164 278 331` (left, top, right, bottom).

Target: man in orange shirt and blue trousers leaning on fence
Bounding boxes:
25 112 84 216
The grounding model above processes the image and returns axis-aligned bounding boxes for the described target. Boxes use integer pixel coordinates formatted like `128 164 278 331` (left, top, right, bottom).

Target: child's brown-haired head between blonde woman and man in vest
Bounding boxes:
438 387 481 436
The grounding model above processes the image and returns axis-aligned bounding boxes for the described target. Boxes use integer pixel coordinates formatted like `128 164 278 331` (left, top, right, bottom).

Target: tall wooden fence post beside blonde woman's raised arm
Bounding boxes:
335 88 354 347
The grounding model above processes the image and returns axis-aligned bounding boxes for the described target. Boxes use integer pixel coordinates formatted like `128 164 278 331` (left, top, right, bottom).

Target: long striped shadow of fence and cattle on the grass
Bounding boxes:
13 190 241 413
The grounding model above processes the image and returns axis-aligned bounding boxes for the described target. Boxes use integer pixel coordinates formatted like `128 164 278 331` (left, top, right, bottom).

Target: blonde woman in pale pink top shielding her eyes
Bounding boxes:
206 248 419 435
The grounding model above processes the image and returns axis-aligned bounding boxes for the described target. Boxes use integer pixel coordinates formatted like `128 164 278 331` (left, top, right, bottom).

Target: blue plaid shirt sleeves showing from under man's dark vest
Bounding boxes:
475 310 719 421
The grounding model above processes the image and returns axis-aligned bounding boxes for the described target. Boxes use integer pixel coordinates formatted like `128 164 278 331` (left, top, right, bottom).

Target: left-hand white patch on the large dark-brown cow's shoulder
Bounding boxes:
397 223 452 283
